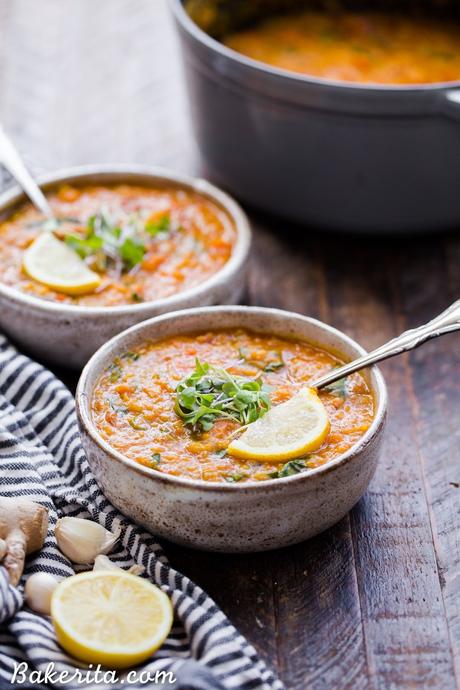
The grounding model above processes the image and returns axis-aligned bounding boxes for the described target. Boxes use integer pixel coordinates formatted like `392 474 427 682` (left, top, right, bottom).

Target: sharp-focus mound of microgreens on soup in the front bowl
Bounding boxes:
175 359 270 433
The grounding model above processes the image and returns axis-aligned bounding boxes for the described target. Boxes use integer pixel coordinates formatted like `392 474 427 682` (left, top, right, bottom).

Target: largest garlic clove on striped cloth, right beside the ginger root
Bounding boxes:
54 517 120 564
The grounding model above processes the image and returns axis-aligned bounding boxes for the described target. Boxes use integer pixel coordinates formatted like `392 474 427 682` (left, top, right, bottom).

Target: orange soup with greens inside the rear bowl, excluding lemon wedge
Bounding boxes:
0 184 236 307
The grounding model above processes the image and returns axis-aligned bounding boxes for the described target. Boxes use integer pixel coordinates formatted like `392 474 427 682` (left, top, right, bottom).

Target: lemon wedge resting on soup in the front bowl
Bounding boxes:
227 388 330 462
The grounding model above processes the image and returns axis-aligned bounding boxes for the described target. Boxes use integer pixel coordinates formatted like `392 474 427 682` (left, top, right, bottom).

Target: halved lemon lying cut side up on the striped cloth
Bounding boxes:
51 570 173 668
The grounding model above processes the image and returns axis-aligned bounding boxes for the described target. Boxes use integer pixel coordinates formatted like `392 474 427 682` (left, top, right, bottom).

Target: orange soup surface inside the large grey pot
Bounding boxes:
224 10 460 84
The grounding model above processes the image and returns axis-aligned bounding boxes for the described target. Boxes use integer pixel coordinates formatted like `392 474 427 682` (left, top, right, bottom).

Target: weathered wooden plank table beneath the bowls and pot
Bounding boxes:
0 0 460 690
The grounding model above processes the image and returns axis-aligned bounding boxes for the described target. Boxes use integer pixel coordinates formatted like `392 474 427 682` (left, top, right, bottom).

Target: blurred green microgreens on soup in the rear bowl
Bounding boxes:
65 209 171 272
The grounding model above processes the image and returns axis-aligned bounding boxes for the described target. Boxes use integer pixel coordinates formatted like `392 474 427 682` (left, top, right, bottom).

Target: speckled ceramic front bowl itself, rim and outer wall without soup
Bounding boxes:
77 307 387 552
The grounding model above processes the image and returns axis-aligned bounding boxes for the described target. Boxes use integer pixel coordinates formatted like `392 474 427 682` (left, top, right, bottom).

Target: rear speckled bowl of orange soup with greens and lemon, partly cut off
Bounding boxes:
0 166 250 368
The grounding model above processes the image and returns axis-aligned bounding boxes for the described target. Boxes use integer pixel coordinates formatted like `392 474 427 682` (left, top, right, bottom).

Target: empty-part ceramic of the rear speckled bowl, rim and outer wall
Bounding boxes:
0 165 251 368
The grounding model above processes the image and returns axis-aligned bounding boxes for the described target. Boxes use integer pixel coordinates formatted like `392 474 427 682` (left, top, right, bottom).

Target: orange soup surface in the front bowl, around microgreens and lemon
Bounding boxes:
92 330 374 482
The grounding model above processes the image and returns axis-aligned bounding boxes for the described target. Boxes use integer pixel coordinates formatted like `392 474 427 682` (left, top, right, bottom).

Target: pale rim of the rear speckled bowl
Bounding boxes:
0 163 252 318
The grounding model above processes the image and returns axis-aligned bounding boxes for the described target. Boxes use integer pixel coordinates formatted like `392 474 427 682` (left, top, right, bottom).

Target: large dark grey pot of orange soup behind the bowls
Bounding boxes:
171 0 460 233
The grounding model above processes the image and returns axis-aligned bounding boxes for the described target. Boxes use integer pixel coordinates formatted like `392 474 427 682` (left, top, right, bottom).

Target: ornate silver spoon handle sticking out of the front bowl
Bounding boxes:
310 300 460 389
